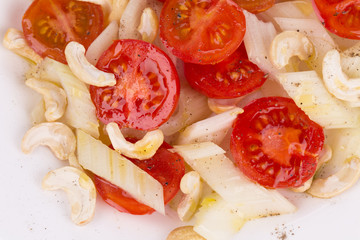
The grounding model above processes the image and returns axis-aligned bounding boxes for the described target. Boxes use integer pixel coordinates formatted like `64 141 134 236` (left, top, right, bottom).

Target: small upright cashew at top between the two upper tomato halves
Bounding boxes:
138 7 159 43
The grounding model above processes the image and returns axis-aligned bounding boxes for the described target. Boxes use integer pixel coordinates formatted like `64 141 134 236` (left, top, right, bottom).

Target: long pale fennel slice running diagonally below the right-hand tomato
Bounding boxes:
174 142 296 219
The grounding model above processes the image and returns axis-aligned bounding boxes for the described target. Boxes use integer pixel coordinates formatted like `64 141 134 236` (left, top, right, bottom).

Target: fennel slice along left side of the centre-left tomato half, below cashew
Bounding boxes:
34 58 99 138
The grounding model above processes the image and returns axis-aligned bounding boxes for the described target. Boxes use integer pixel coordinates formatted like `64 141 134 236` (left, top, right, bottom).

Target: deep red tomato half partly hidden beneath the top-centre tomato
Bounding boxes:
184 48 267 99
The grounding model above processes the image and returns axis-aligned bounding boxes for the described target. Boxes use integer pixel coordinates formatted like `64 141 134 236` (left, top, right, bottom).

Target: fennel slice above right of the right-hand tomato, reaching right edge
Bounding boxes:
279 71 360 128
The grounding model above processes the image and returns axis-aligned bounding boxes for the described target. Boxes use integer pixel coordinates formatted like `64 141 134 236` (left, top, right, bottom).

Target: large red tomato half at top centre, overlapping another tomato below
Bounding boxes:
160 0 246 64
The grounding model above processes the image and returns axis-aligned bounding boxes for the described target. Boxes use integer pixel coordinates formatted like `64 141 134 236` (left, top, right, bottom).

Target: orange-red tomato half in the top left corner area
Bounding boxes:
22 0 104 63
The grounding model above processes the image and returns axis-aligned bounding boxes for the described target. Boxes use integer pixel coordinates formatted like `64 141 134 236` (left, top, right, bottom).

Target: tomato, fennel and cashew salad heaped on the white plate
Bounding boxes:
4 1 359 239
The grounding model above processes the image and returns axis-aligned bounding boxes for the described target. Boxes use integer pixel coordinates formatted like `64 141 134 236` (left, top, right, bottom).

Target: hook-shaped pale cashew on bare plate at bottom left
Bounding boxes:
42 166 96 225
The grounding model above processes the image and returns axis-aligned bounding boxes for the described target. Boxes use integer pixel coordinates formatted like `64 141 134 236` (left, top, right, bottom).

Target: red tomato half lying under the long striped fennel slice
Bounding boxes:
93 142 185 215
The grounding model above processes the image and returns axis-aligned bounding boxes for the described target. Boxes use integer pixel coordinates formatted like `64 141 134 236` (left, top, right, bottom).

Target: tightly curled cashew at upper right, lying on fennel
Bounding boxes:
270 31 315 69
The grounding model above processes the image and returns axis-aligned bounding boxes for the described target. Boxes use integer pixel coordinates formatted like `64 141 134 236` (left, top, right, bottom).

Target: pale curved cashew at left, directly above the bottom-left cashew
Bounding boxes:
21 122 76 160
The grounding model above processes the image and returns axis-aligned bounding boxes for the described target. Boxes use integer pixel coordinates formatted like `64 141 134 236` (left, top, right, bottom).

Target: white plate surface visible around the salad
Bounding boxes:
0 0 360 240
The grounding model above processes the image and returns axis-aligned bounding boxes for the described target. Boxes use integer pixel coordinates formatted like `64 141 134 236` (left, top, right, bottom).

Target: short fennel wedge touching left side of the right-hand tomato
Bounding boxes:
176 108 244 144
